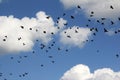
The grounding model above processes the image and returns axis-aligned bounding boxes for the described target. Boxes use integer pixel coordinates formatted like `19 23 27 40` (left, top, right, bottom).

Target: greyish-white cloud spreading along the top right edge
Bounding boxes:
60 0 120 19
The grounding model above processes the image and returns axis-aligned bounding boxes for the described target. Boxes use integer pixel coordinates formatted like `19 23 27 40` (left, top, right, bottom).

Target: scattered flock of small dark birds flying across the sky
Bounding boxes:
0 5 120 80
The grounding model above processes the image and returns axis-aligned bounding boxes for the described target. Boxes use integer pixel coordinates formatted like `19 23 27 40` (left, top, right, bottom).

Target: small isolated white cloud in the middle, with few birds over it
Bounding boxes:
60 26 92 48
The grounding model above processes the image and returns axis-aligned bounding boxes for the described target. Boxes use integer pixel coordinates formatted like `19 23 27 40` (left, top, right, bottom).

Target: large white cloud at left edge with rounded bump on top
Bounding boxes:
0 11 58 53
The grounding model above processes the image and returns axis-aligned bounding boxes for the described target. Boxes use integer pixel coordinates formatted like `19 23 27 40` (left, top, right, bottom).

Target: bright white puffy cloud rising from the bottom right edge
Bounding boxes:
60 64 120 80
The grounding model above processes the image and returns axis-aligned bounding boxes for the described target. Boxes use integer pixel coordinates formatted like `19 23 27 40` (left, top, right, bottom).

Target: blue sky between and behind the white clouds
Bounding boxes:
0 0 120 80
